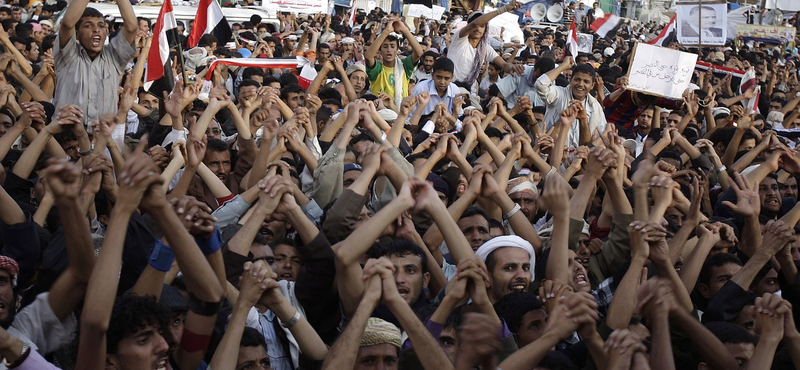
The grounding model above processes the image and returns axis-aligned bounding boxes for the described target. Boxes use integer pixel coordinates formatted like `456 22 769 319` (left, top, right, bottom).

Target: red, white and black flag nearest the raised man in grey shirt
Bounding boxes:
144 1 179 99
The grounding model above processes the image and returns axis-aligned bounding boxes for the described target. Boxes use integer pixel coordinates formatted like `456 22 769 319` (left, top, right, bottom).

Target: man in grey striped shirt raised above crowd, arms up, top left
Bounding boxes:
53 0 139 128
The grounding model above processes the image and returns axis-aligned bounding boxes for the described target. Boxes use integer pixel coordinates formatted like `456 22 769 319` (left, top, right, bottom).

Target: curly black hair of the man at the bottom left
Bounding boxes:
106 294 170 354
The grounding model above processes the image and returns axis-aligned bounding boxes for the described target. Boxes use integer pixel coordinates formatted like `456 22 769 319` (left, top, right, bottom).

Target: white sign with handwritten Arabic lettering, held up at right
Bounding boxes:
628 43 697 99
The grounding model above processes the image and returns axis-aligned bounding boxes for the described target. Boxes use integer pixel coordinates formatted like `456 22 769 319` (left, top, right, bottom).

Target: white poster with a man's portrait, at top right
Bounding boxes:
676 1 728 46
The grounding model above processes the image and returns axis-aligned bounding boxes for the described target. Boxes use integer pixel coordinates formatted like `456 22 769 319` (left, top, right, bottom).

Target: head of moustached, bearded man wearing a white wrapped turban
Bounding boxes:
475 235 536 304
